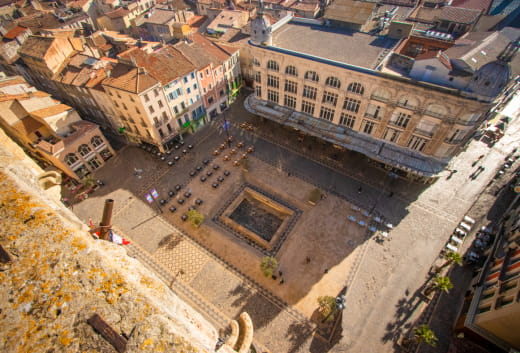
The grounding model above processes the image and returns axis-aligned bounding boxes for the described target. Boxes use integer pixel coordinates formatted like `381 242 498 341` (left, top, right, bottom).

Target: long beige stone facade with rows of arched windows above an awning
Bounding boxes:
248 11 496 181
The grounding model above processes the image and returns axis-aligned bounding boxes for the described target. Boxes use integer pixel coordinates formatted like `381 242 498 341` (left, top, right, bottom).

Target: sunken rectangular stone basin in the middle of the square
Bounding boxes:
218 186 295 252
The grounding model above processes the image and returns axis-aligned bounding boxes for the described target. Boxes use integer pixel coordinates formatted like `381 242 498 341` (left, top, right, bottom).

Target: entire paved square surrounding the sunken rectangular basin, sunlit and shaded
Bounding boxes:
73 92 518 352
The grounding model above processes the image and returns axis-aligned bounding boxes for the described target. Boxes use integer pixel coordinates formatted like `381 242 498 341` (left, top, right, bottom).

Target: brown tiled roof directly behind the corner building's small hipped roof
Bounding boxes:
119 46 196 85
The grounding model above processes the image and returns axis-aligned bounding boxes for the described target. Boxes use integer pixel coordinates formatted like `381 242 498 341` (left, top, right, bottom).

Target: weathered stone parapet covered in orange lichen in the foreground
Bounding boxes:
0 130 231 352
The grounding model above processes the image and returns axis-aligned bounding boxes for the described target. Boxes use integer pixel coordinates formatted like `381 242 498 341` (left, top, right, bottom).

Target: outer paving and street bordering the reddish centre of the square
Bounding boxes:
74 92 518 352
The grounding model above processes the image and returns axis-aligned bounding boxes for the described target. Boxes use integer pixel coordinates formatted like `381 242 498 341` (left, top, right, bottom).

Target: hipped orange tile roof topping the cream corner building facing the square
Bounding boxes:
103 63 158 93
